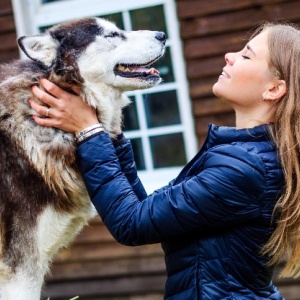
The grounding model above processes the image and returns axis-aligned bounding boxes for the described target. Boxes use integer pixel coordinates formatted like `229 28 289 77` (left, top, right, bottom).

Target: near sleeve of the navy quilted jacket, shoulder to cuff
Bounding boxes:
78 134 266 245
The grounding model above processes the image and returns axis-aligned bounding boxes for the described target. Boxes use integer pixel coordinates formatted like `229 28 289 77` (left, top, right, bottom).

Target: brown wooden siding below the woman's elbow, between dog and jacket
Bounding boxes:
43 218 165 300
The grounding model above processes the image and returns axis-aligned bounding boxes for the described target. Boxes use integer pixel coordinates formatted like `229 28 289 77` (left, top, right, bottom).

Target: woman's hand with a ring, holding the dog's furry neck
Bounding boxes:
28 79 99 133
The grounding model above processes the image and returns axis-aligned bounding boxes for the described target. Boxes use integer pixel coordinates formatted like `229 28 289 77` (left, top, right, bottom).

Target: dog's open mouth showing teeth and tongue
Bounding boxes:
114 58 160 79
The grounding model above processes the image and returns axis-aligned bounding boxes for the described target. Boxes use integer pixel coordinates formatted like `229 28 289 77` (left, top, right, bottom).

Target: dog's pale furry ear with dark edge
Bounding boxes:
18 34 59 68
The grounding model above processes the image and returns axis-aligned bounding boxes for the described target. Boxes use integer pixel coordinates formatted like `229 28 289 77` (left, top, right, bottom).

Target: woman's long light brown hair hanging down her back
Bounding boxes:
254 23 300 277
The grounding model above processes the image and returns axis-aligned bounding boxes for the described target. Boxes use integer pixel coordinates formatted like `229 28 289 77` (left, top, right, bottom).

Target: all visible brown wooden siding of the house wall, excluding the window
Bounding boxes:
0 0 300 300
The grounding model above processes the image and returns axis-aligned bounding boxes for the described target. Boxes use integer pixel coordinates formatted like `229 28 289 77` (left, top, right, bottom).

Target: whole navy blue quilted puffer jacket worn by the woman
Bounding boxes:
78 125 283 300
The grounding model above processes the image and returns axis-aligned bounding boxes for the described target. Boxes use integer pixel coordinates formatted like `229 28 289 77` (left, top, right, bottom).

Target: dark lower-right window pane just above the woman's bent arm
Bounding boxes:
150 133 186 168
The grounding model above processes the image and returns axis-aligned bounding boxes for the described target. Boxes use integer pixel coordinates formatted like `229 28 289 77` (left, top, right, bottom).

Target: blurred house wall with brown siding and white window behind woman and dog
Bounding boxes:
0 0 300 300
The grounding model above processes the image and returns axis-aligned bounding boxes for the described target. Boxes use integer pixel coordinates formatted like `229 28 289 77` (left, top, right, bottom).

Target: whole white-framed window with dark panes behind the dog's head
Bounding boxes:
13 0 196 192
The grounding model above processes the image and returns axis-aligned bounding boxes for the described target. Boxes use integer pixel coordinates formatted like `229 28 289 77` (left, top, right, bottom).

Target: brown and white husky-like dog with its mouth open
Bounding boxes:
0 18 166 300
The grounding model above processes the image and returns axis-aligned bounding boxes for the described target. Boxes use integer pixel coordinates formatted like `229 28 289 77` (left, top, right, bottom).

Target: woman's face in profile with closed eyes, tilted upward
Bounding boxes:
213 31 274 109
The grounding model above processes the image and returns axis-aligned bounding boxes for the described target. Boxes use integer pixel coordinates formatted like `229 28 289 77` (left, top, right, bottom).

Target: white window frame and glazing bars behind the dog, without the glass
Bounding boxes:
12 0 197 193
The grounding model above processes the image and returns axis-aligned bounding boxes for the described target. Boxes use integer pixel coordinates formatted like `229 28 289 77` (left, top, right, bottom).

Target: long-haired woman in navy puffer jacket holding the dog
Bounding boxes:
30 24 300 300
